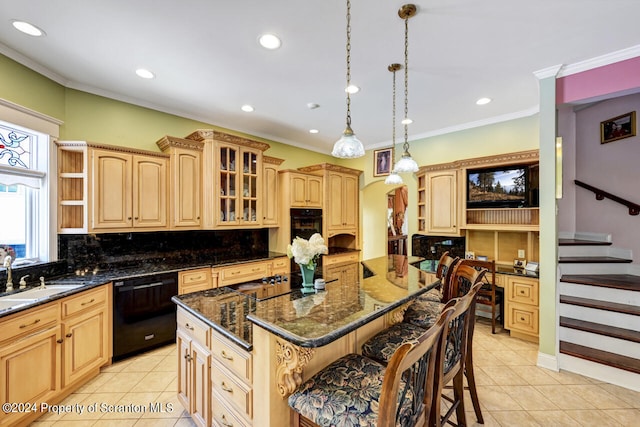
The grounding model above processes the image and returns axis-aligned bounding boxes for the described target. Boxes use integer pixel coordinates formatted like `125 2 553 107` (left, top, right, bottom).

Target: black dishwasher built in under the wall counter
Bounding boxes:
113 273 178 361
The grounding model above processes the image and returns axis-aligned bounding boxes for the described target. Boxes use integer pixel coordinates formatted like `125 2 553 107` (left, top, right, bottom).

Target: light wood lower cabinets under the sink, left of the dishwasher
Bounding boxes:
0 285 111 426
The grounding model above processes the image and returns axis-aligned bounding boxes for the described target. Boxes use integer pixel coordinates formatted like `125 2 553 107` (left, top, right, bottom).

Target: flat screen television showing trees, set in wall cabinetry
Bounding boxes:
467 164 539 209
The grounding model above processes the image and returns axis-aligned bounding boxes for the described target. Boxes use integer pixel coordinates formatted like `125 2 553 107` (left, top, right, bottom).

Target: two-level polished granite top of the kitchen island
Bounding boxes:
173 255 437 350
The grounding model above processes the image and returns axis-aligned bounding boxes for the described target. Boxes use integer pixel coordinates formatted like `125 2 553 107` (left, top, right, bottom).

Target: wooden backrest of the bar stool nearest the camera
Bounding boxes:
377 307 454 427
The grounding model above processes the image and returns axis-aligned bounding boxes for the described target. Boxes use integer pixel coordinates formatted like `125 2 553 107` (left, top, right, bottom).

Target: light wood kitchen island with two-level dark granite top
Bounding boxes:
173 255 435 427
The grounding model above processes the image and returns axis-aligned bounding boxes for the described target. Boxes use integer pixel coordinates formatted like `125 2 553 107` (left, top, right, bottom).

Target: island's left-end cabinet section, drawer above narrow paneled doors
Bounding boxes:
176 308 211 426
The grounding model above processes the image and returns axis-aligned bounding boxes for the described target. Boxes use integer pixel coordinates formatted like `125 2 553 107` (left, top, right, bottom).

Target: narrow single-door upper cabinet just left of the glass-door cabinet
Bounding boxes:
156 136 204 230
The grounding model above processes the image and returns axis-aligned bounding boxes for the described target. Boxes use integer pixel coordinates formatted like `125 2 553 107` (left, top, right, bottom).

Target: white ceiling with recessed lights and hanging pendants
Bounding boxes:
0 0 640 153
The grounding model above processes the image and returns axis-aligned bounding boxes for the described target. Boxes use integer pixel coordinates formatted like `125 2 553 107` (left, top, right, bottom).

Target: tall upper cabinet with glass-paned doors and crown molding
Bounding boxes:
187 129 269 229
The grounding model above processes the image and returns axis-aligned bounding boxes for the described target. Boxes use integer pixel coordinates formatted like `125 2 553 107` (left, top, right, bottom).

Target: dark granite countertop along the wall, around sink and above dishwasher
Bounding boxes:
0 252 287 318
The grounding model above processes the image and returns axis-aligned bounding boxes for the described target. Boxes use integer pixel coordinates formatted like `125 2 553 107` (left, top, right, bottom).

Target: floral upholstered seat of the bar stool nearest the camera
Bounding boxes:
289 354 416 427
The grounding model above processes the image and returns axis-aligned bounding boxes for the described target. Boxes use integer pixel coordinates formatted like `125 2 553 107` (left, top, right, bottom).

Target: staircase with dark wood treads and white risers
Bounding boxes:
558 235 640 391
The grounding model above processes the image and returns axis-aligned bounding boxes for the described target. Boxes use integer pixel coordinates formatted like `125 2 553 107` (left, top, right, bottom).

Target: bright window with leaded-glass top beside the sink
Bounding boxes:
0 121 50 263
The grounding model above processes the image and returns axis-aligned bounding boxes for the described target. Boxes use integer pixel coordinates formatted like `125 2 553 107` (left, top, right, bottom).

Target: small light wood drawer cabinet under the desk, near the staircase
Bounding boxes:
505 275 539 342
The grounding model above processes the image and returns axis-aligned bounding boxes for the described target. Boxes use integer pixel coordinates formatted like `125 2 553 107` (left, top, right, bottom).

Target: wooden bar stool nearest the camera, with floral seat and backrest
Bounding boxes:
288 309 454 427
